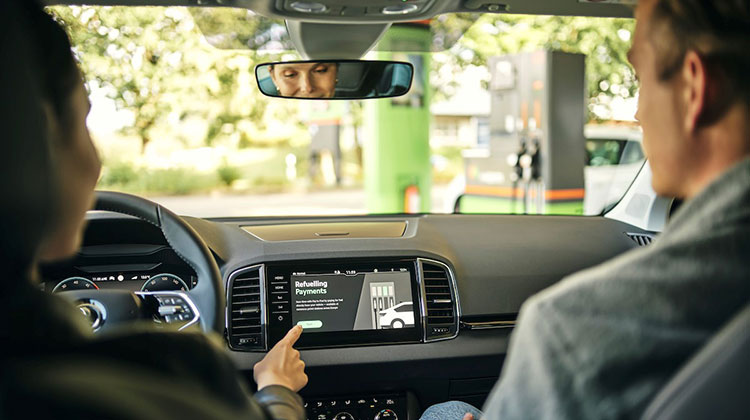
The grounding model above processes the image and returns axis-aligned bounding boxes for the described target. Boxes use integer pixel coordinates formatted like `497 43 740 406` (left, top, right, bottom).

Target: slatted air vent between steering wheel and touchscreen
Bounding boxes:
227 265 266 350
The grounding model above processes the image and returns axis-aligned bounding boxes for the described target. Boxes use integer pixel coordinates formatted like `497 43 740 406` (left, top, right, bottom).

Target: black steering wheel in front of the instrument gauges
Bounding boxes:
60 191 225 334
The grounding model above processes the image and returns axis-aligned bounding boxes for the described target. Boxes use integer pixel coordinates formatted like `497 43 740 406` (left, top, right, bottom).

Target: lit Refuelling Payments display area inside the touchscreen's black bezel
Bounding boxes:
291 268 414 332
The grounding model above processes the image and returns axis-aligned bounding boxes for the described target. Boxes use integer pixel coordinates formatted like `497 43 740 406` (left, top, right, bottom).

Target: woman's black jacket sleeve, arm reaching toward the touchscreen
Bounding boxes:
0 289 305 420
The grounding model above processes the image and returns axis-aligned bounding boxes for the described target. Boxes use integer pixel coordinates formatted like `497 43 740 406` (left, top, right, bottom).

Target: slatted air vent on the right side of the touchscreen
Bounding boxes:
418 259 458 341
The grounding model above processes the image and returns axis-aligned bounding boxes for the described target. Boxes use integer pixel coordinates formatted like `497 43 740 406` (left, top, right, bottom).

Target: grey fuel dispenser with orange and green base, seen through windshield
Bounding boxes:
457 51 586 214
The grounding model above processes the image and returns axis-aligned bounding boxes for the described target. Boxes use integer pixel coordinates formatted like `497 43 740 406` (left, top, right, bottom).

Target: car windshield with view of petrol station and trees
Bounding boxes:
50 6 644 217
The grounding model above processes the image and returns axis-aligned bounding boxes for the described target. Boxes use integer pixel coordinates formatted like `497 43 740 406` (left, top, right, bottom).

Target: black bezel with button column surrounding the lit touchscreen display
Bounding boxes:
266 259 423 349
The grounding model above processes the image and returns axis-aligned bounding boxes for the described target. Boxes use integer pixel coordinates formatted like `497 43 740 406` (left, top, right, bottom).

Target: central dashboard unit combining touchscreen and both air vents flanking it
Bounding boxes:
226 258 459 351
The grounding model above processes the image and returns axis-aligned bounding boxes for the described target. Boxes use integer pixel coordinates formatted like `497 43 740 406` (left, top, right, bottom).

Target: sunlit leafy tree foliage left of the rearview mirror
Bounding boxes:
51 6 306 150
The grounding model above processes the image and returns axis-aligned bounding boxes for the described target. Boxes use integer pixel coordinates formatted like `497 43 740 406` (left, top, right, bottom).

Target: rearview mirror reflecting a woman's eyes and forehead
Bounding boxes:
255 60 414 99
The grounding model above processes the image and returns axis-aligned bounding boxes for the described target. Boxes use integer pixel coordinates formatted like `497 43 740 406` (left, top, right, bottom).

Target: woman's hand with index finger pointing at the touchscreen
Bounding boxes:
253 325 307 392
